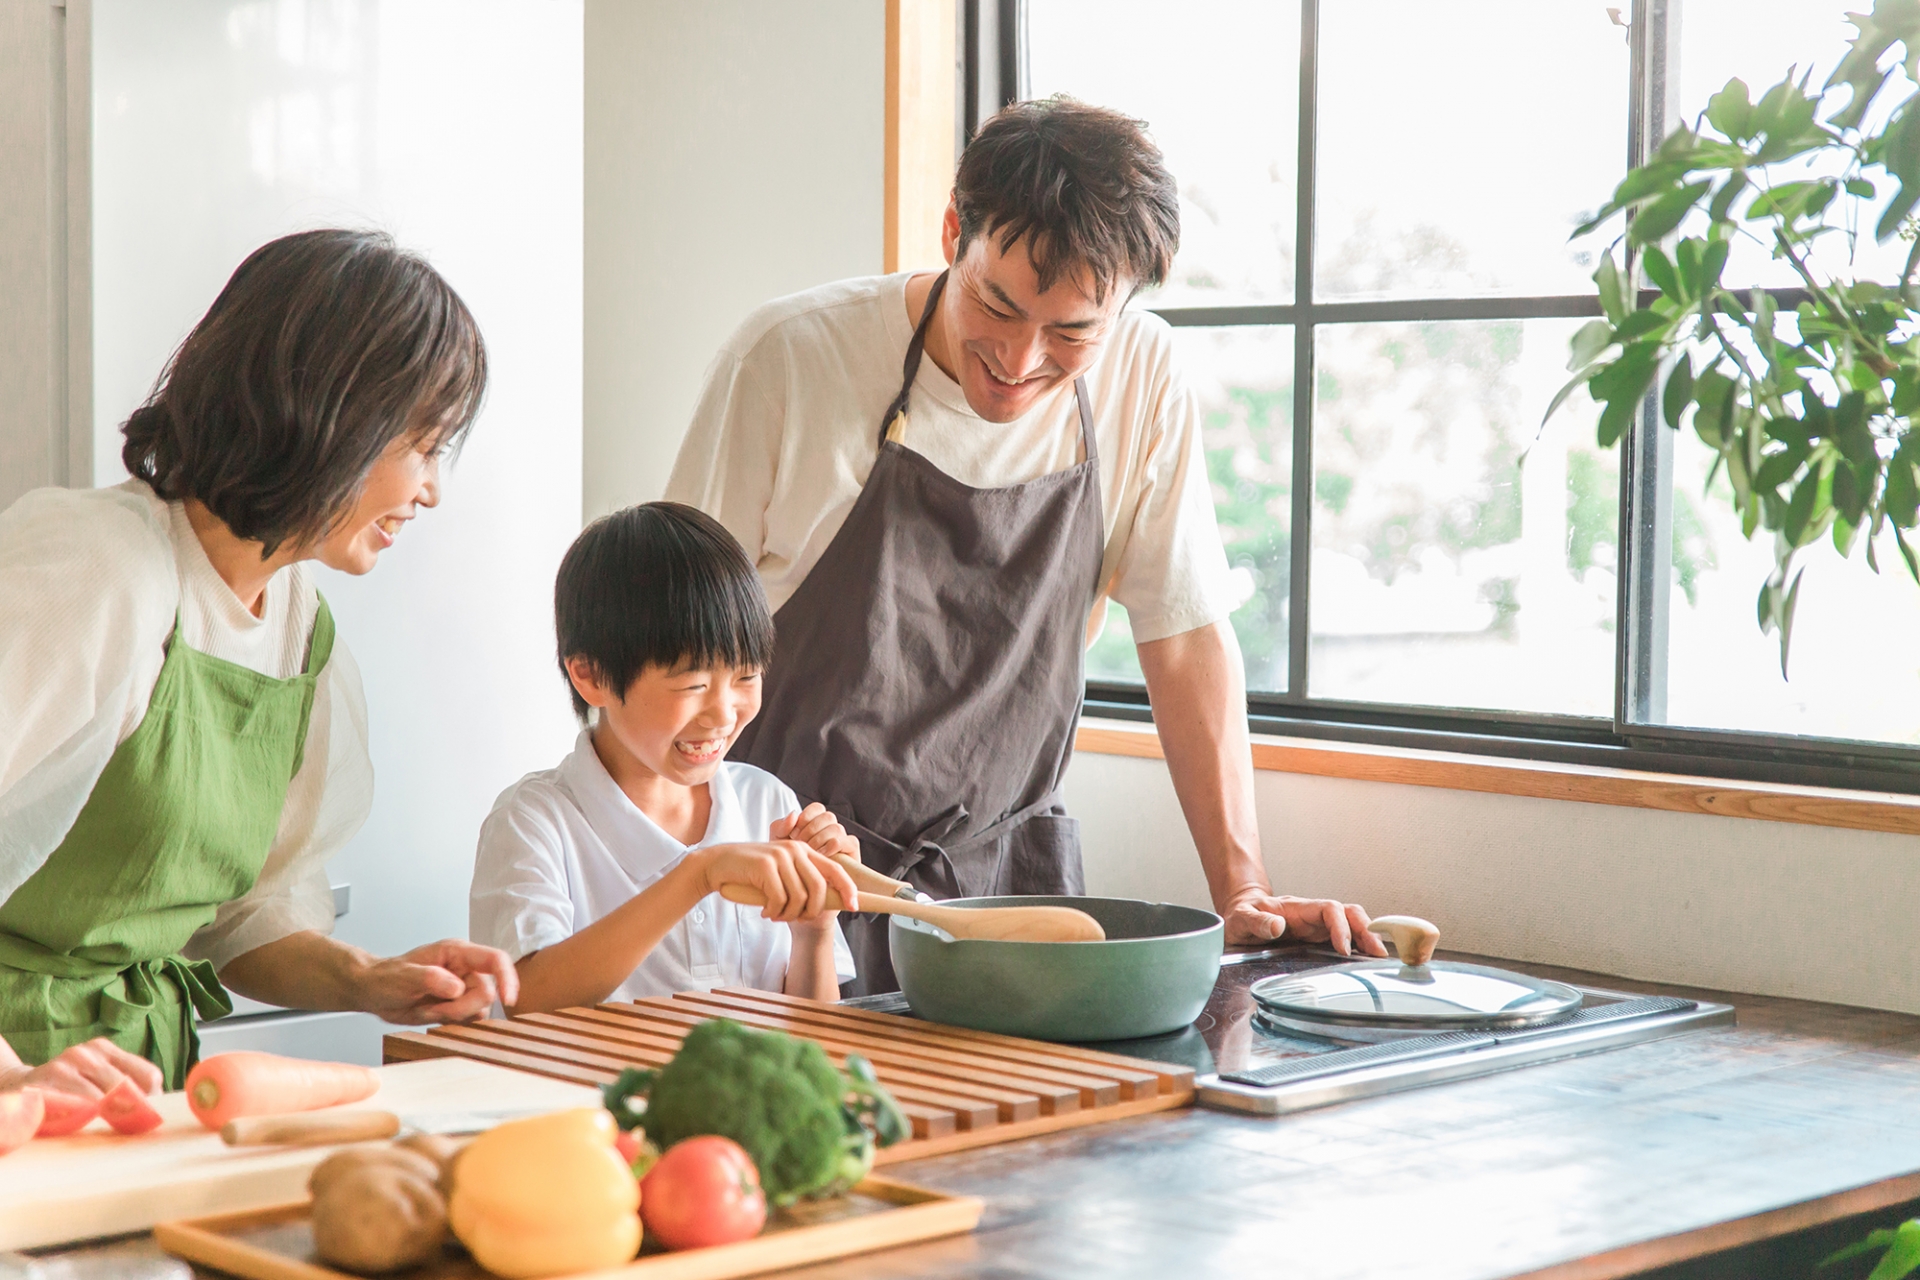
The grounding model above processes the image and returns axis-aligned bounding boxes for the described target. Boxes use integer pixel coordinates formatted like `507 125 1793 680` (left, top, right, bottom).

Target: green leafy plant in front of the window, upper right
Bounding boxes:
1548 0 1920 675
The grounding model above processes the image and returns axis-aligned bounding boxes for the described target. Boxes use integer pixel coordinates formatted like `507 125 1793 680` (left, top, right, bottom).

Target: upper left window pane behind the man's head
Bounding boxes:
1025 0 1300 307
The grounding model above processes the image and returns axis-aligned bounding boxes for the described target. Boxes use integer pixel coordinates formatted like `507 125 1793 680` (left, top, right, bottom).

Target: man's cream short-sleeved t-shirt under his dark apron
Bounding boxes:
666 273 1236 641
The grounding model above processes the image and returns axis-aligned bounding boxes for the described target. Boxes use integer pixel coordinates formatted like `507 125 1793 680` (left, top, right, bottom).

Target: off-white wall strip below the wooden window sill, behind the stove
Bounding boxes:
1068 754 1920 1013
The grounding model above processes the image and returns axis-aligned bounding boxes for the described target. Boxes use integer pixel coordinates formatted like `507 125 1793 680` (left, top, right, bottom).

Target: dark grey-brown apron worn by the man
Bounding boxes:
732 273 1104 994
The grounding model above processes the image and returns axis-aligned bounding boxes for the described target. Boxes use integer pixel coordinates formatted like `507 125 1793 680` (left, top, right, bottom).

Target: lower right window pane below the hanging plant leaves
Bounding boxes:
1665 432 1920 743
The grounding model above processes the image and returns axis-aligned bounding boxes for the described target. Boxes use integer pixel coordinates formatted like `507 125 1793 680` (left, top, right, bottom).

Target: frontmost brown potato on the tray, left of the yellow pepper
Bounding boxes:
313 1151 447 1274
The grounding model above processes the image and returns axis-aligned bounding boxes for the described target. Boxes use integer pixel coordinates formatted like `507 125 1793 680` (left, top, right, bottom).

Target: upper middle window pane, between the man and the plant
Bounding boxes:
1313 0 1628 299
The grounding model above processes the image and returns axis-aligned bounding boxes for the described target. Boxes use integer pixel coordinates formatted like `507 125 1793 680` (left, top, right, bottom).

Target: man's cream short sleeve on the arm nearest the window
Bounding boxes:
1110 364 1238 643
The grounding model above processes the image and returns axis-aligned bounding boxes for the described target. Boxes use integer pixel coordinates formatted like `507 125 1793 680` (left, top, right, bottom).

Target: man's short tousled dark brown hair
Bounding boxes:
954 96 1181 301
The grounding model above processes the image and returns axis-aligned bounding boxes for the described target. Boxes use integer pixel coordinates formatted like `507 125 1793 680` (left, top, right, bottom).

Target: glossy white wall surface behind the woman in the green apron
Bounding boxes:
94 0 582 954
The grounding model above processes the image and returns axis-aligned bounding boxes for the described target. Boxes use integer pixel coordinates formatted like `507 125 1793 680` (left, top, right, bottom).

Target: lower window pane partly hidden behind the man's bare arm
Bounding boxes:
1087 326 1294 693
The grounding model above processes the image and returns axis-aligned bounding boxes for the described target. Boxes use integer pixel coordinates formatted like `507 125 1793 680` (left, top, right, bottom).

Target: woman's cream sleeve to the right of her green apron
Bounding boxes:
186 639 372 969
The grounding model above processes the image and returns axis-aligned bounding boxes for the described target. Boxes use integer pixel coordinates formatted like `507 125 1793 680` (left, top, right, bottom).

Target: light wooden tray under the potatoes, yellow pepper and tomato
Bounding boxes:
154 1178 981 1280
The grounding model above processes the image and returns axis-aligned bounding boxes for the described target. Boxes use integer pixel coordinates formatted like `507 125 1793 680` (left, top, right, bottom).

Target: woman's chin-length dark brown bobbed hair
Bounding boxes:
121 230 486 555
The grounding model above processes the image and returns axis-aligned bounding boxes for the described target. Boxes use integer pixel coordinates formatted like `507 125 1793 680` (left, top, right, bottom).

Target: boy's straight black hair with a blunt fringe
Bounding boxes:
553 503 774 720
